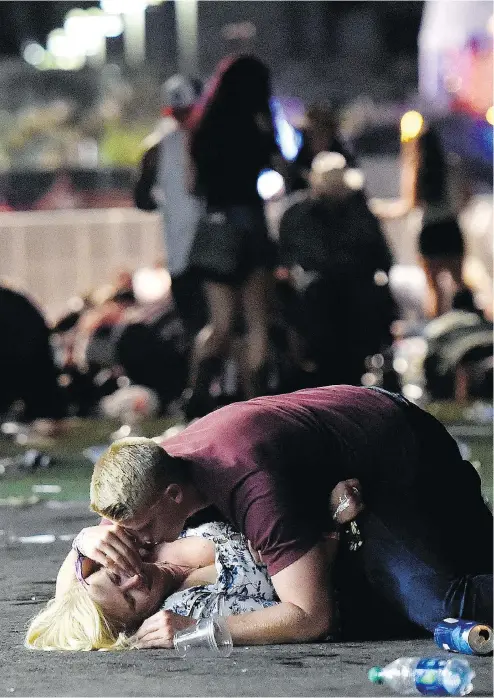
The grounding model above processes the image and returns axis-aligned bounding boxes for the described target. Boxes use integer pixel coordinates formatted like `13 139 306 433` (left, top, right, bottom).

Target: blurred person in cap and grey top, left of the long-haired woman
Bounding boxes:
134 75 207 340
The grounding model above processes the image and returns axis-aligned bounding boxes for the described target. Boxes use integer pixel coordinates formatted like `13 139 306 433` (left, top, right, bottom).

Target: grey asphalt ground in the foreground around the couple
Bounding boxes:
0 501 493 697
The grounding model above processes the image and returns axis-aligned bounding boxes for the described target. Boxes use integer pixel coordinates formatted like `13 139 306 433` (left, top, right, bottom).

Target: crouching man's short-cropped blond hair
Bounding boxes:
90 437 176 521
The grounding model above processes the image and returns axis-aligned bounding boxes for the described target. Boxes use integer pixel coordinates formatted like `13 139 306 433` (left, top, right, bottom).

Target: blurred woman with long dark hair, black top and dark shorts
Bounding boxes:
186 55 282 418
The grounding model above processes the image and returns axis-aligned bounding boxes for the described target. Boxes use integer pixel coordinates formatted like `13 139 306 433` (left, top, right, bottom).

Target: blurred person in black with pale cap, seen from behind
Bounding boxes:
277 153 395 385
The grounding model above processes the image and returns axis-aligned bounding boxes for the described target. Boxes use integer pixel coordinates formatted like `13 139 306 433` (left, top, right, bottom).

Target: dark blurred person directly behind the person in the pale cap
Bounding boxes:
288 104 357 191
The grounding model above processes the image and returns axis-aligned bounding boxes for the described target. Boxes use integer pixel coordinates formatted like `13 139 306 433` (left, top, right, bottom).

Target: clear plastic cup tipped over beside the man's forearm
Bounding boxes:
173 616 233 659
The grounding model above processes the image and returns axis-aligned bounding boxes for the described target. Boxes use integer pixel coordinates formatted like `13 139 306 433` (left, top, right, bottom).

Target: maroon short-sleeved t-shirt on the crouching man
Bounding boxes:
162 385 415 575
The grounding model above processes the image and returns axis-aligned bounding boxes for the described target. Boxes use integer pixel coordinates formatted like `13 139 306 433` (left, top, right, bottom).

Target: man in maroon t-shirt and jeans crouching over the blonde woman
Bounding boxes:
63 386 492 647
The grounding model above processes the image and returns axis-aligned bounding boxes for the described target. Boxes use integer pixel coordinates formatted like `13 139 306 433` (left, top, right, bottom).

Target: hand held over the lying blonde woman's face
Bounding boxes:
74 524 142 576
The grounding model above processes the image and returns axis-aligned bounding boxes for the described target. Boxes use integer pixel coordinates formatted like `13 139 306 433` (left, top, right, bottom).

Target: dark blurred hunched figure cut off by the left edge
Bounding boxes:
0 286 67 427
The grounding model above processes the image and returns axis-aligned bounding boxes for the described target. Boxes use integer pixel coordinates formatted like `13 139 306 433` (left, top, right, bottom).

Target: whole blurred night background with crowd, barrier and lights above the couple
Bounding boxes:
0 0 494 435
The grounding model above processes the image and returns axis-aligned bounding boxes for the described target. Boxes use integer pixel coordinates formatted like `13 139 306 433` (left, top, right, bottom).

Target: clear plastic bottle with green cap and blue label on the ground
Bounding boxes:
369 657 475 696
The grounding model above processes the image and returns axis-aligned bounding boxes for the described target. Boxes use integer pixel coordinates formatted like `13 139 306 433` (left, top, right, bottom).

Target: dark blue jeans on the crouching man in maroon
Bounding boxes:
336 388 493 639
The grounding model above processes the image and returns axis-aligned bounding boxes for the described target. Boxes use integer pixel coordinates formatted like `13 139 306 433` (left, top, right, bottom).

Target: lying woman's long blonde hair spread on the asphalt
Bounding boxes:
24 583 131 652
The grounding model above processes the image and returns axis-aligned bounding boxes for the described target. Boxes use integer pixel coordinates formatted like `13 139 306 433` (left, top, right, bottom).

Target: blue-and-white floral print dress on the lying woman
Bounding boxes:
162 523 278 618
